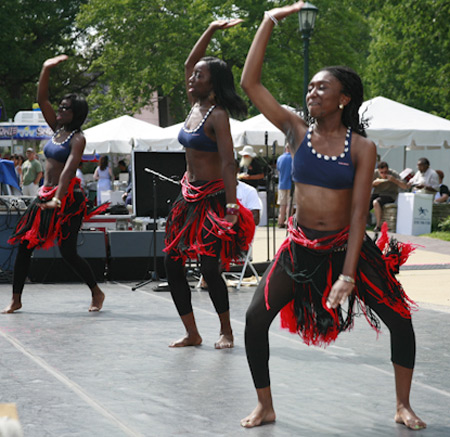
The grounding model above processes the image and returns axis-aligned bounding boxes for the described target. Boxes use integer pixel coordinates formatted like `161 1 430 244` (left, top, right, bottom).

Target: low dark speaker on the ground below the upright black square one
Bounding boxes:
107 231 165 281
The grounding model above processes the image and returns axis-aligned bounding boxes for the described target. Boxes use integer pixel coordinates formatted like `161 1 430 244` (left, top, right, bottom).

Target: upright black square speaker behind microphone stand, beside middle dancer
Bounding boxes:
132 151 186 218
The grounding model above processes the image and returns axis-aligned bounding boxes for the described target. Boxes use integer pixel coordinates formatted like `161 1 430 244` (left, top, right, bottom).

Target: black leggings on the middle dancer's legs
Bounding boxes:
164 233 230 316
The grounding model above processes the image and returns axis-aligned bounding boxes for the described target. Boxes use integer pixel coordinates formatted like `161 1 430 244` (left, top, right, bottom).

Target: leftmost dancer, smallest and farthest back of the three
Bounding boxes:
3 55 107 313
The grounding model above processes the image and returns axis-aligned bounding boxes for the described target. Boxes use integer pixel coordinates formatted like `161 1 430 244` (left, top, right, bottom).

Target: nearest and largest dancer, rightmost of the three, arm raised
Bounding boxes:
241 1 426 429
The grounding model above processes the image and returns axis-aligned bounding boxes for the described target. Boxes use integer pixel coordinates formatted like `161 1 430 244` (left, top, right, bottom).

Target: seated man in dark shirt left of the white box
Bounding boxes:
369 161 408 232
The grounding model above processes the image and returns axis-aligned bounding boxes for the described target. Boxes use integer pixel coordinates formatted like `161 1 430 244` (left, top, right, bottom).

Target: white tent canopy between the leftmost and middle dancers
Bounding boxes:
84 115 163 154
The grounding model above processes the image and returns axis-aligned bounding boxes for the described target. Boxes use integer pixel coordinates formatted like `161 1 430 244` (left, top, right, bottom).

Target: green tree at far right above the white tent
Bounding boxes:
365 0 450 118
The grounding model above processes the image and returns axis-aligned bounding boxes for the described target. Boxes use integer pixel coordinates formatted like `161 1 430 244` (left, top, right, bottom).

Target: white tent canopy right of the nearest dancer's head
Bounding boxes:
360 97 450 149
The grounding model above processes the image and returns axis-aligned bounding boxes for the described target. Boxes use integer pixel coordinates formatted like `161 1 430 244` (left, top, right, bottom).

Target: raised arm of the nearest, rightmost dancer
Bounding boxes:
241 1 304 135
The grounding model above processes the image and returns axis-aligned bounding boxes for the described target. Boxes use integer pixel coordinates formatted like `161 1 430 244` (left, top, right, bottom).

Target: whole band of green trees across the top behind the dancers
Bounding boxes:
0 0 450 124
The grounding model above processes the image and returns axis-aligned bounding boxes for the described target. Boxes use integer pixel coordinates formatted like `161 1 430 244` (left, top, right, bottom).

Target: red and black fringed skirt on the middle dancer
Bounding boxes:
164 174 255 268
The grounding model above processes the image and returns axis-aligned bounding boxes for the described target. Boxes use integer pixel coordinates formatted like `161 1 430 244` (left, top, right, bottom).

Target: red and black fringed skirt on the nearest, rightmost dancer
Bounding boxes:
265 217 416 345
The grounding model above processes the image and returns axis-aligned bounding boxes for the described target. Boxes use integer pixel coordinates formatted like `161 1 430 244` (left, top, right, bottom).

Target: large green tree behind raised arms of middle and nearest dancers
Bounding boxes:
78 0 369 123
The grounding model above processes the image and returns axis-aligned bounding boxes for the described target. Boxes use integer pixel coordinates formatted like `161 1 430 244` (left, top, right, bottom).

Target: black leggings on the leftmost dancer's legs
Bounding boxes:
13 215 97 294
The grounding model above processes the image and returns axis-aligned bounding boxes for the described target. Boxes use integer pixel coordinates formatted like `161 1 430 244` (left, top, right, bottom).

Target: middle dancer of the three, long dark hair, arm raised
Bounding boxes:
165 20 255 349
